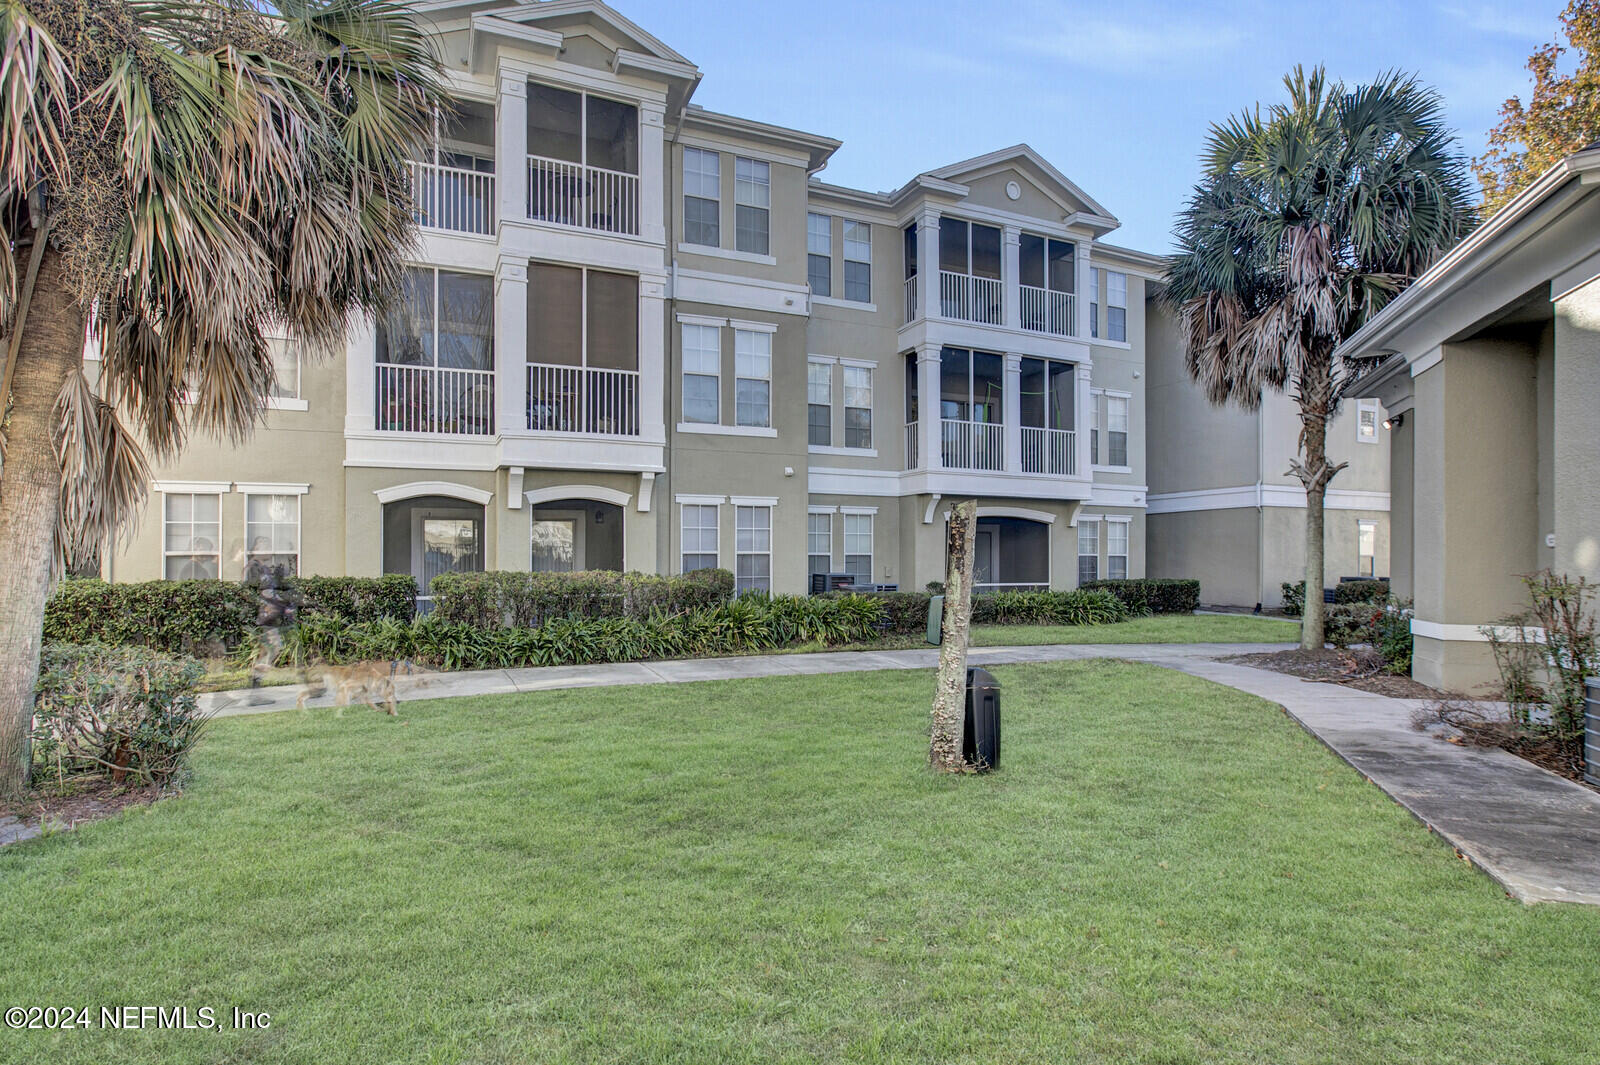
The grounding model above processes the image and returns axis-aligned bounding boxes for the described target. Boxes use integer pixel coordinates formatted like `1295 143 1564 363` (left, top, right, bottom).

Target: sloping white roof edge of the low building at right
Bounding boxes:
1338 147 1600 358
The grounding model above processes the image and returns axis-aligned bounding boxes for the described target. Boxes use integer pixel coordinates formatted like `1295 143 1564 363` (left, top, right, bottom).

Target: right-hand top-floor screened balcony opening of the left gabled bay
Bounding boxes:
528 83 640 235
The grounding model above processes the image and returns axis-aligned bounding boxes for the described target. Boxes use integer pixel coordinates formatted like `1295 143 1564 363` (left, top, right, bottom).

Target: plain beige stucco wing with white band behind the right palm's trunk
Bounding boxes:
1146 288 1390 608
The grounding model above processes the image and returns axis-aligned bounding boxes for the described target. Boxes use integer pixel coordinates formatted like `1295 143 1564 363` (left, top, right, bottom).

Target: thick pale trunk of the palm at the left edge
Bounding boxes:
0 249 83 796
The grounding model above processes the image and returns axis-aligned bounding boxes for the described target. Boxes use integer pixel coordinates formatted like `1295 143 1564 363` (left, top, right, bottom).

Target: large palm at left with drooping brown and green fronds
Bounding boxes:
0 0 446 795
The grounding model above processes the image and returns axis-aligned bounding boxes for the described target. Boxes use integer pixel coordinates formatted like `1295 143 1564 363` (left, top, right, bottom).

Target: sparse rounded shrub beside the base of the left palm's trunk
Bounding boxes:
32 643 210 787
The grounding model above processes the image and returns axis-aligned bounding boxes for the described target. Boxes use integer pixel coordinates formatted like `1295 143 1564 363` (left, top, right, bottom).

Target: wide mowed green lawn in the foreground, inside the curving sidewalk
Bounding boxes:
0 662 1600 1065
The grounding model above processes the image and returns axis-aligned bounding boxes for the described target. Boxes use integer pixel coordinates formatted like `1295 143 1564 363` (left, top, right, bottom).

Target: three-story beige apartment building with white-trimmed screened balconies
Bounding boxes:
107 0 1160 595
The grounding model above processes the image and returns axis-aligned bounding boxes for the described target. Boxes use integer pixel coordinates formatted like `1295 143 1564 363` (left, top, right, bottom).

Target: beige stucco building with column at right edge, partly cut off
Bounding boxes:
1346 146 1600 691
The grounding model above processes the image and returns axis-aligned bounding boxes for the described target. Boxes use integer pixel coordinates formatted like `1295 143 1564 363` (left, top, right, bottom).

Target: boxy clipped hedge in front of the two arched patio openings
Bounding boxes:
432 569 733 628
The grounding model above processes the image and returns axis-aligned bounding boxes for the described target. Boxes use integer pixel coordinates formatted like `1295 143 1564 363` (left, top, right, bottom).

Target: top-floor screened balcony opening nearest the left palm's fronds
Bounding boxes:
406 101 496 237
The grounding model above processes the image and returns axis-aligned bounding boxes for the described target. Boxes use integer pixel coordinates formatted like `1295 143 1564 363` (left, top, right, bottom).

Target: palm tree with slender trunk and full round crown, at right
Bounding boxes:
1166 67 1477 649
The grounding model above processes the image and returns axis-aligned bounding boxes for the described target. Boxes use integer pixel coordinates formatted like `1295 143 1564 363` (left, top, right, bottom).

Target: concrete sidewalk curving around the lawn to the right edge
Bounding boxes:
203 643 1600 905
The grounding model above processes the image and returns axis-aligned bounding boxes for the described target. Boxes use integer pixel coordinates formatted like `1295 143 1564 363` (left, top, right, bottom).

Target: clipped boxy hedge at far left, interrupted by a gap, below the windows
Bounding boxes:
43 574 416 657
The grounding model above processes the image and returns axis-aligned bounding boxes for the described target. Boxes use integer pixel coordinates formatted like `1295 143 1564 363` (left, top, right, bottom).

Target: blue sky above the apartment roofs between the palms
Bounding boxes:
611 0 1565 251
